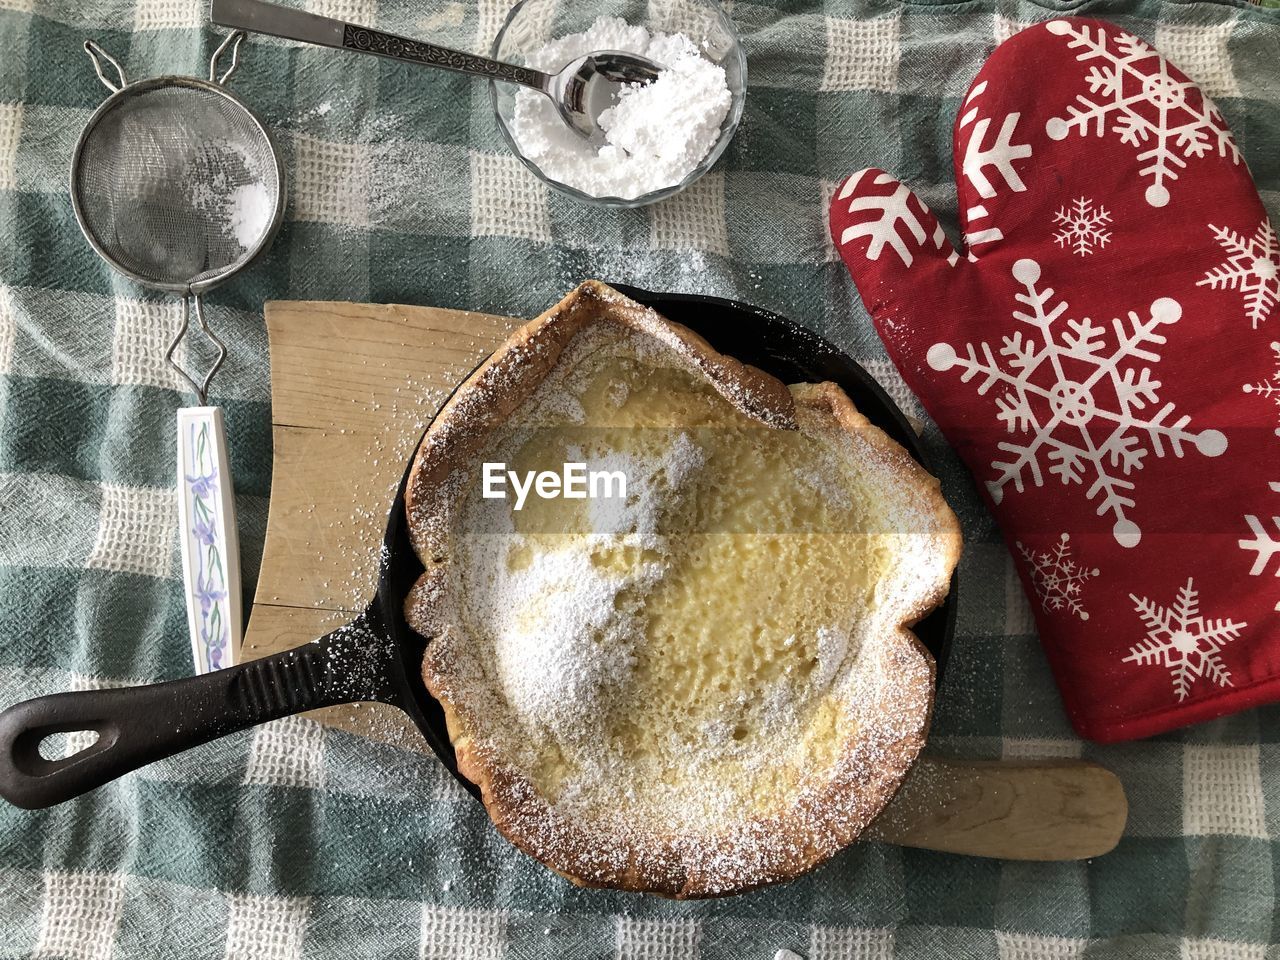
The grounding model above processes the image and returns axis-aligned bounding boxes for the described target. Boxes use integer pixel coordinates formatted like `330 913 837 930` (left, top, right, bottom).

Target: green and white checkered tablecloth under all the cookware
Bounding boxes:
0 0 1280 960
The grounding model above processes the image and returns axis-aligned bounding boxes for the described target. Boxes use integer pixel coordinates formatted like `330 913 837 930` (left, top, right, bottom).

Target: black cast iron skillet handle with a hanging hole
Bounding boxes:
0 611 399 809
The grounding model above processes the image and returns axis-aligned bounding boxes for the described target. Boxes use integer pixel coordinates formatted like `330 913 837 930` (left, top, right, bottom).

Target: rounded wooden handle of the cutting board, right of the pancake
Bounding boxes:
863 756 1129 860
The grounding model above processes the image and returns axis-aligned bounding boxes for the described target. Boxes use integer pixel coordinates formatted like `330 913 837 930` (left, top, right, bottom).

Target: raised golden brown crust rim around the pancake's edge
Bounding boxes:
406 282 960 899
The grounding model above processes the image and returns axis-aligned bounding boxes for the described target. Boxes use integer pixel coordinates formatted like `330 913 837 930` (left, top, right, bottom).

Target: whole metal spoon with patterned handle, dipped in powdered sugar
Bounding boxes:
209 0 662 140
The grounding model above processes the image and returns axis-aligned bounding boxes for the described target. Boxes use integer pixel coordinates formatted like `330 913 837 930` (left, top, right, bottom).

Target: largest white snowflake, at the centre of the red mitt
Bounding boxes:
927 260 1226 547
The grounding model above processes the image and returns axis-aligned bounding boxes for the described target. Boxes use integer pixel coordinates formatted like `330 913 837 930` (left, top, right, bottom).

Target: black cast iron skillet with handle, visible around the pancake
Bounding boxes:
0 287 956 808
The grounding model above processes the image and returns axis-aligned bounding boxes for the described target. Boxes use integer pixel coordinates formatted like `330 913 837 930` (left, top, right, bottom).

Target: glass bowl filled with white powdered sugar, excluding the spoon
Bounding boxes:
489 0 746 207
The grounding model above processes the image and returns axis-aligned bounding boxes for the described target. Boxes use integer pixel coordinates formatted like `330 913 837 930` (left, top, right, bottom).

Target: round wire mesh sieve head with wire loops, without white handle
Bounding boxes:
70 33 284 403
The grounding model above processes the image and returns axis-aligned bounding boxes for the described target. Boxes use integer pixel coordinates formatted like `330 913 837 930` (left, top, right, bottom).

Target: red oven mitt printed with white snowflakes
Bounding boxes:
831 19 1280 740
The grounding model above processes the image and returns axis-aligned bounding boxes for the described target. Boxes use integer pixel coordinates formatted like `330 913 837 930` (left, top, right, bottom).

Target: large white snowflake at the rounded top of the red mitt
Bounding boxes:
1044 20 1240 207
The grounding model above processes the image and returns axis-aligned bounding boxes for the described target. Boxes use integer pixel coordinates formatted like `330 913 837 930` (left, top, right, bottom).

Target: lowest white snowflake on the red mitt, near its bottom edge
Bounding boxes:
1124 577 1248 700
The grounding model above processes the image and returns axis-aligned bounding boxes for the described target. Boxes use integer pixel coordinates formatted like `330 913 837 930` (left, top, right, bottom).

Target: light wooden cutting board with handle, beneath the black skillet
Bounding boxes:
242 302 1128 860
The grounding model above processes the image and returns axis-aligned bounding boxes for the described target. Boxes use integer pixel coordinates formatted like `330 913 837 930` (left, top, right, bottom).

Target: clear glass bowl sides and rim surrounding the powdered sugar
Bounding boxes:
489 0 746 207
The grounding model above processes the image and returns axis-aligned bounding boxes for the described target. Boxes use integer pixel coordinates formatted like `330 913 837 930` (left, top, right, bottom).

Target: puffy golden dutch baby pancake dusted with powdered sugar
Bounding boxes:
406 282 960 897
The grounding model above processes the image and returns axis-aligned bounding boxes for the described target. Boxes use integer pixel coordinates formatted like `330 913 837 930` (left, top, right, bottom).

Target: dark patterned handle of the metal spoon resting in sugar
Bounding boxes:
209 0 552 92
